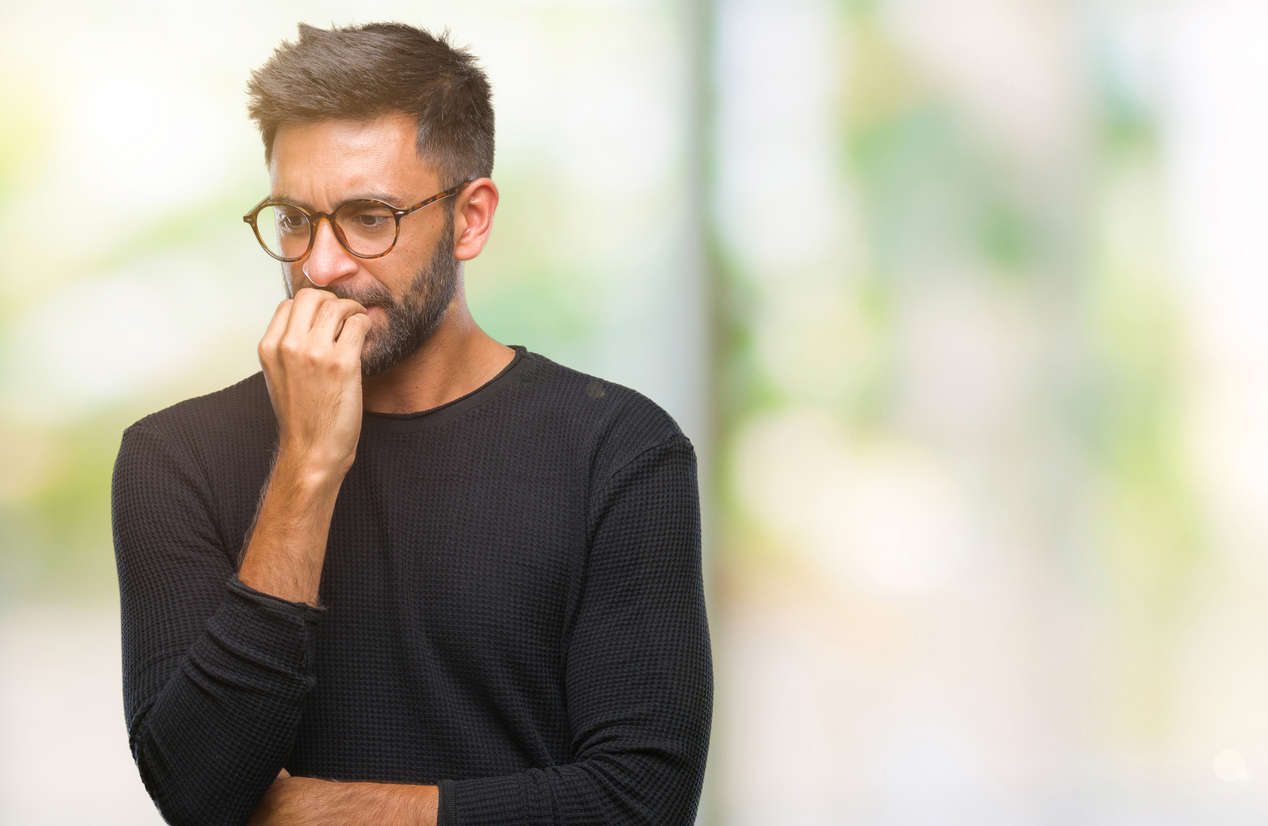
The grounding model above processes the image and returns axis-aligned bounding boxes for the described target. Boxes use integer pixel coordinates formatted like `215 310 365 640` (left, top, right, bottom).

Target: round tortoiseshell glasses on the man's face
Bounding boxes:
242 179 474 264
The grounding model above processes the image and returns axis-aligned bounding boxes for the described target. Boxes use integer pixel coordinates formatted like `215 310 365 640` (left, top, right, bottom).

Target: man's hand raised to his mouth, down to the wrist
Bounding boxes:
259 287 370 473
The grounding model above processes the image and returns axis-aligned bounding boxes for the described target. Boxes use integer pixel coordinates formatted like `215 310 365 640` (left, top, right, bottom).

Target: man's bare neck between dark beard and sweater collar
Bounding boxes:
361 287 515 414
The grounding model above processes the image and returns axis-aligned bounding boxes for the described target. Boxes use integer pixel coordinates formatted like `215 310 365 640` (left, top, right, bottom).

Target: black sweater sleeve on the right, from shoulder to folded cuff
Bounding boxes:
439 434 713 826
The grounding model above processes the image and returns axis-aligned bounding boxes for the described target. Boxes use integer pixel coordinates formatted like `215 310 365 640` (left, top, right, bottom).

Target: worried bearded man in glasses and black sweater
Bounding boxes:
112 24 713 825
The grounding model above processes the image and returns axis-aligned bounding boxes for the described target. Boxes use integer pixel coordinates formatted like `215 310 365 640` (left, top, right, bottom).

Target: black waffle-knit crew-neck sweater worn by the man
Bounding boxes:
112 346 713 826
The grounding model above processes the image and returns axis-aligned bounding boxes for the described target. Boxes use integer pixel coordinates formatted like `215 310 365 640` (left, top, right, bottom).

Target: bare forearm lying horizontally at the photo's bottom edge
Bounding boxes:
250 777 437 826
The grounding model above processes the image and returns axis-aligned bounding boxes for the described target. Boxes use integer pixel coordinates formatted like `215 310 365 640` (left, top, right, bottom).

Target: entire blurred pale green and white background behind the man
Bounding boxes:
0 0 1268 823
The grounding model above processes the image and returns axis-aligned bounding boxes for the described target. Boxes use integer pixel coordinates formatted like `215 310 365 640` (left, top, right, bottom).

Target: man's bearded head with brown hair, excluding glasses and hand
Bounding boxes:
249 24 497 376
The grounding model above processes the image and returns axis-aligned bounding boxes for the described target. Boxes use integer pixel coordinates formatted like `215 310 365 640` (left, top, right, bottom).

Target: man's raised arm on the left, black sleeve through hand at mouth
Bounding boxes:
112 291 368 823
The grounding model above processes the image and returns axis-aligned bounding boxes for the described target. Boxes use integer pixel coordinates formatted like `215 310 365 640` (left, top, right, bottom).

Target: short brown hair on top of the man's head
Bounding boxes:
247 23 493 187
